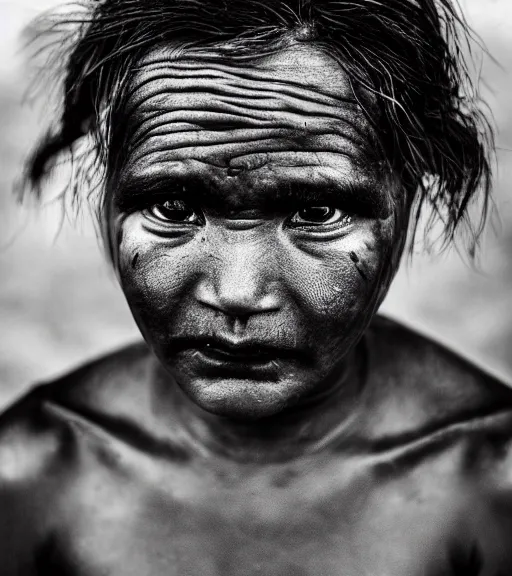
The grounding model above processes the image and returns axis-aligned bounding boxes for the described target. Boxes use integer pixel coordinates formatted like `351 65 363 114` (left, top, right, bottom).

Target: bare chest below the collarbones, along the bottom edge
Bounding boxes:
35 466 460 576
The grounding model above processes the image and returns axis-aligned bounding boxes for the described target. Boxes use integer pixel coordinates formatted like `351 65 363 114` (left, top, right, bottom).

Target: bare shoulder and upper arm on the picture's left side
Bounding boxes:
0 344 160 576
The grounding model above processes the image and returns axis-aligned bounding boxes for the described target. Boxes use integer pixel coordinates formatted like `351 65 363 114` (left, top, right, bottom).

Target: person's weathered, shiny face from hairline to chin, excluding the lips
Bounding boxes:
111 46 403 417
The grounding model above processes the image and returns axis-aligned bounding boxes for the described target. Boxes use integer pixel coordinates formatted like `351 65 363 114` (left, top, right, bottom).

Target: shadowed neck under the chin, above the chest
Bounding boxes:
150 345 364 462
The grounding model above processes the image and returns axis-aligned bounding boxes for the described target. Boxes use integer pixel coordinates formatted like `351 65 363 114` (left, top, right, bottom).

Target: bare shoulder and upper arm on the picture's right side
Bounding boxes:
367 318 512 575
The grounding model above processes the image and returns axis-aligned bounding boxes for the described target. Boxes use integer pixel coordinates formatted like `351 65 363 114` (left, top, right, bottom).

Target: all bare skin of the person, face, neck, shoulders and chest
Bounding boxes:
0 41 512 576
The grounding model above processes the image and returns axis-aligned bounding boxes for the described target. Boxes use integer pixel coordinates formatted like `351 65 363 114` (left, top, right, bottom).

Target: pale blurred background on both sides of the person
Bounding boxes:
0 0 512 409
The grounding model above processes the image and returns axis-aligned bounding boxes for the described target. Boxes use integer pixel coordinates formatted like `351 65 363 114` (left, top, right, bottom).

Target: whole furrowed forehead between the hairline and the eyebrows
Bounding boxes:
115 44 375 198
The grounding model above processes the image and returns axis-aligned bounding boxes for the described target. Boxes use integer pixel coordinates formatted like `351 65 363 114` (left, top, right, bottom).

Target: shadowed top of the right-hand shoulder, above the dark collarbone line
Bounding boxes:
365 316 512 437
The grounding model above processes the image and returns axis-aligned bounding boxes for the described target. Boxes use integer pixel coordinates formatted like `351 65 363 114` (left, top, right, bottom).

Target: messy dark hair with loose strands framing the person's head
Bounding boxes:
25 0 494 254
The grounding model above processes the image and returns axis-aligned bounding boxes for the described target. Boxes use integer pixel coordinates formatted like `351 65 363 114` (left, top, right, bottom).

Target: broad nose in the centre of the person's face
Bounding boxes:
196 231 281 318
